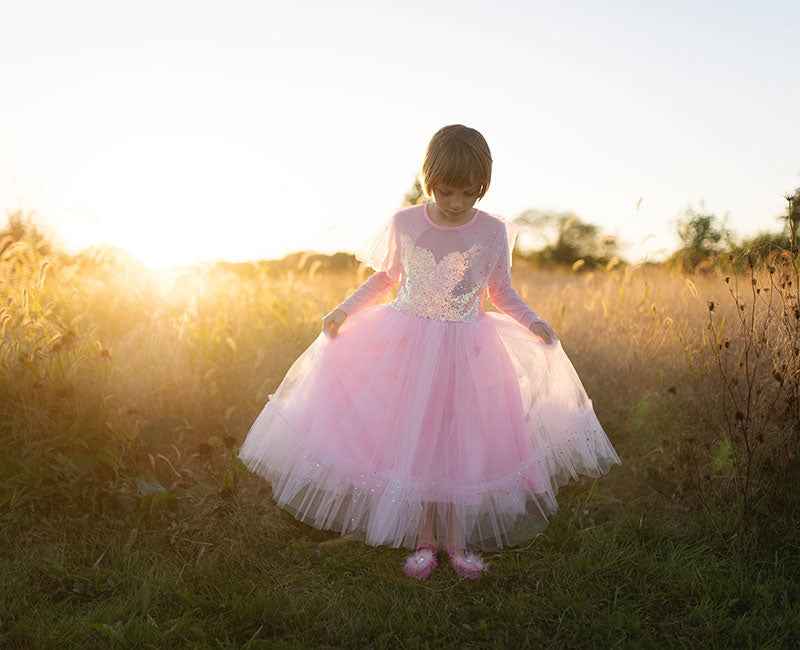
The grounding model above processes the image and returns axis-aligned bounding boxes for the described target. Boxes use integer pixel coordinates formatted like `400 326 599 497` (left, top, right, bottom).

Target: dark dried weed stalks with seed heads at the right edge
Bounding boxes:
693 192 800 530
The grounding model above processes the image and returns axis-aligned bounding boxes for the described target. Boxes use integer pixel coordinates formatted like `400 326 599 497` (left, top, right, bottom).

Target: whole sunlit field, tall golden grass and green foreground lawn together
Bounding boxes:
0 230 800 648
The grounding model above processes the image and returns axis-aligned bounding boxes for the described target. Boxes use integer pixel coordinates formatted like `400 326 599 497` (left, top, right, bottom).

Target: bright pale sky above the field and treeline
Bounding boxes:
0 0 800 266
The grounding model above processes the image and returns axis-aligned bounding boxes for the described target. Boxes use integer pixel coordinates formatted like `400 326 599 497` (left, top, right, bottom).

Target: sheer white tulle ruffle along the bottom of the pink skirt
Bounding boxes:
239 402 619 550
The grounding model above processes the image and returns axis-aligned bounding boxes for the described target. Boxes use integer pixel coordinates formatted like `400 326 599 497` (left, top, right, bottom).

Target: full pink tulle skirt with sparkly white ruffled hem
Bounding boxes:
239 305 619 549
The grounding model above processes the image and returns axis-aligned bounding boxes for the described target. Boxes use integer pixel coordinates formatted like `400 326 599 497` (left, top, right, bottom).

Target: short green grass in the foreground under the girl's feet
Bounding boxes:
2 479 800 647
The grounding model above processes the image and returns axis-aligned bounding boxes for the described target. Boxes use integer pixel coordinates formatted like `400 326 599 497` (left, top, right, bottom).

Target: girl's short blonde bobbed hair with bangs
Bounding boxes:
421 124 492 198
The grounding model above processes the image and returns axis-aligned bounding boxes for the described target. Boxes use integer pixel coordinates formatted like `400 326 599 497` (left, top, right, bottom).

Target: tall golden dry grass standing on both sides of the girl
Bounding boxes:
0 209 797 536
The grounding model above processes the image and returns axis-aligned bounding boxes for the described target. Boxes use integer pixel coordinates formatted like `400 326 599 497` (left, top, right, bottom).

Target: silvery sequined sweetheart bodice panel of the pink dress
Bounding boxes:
392 236 485 321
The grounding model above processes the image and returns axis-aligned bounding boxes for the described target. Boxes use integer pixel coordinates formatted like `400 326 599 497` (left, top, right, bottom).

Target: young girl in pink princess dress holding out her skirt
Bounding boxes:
239 125 620 579
